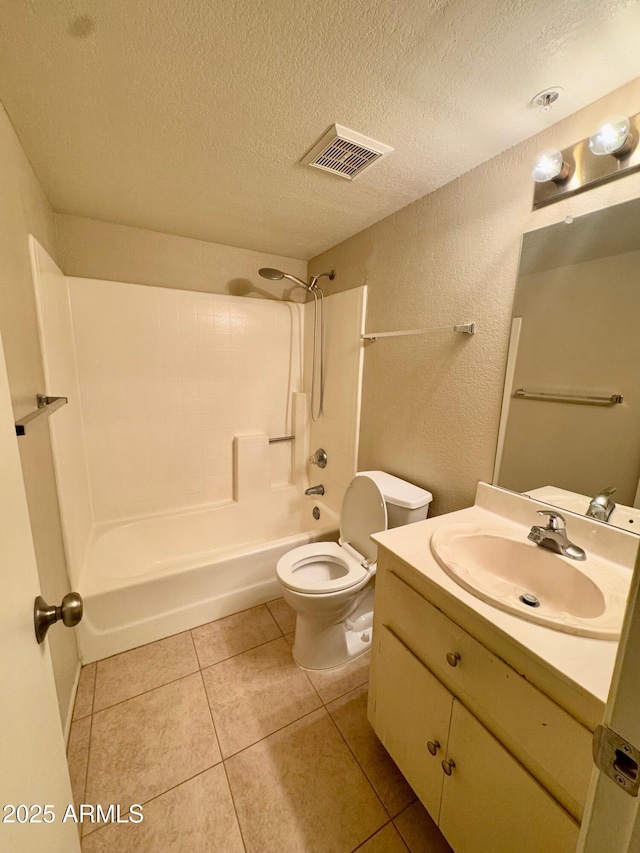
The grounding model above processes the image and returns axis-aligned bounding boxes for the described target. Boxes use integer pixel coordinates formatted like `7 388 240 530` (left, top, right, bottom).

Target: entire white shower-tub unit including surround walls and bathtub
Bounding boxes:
30 237 366 663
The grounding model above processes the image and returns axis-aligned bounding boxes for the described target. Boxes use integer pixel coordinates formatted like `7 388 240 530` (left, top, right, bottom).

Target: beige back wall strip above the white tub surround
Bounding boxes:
55 213 307 302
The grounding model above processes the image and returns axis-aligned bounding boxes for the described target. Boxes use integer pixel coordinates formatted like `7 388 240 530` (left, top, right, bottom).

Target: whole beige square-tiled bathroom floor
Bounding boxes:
68 599 450 853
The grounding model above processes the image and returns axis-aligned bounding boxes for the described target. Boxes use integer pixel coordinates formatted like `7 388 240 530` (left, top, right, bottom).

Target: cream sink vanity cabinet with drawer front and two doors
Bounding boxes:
369 544 598 853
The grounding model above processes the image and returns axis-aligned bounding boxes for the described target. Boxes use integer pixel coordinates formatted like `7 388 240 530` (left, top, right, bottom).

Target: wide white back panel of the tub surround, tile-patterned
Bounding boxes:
37 278 302 524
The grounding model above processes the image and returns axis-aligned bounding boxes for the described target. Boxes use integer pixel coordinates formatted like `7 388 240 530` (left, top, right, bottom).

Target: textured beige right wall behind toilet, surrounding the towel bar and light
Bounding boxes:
309 80 640 514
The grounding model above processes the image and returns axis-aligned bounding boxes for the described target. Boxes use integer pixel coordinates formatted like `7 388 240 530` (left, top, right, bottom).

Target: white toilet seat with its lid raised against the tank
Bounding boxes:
276 476 387 594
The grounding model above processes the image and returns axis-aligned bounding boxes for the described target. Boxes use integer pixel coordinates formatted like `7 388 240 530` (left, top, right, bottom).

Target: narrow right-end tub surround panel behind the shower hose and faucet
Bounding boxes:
304 284 367 513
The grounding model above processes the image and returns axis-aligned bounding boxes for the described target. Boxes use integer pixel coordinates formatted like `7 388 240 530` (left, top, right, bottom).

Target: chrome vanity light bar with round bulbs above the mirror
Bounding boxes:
532 113 640 210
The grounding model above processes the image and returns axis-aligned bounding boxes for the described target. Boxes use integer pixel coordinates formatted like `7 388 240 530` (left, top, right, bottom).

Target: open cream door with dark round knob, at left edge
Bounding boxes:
0 332 80 853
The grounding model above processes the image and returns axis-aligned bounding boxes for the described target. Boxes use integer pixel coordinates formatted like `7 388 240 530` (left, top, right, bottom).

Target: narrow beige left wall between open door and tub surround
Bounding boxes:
0 100 78 724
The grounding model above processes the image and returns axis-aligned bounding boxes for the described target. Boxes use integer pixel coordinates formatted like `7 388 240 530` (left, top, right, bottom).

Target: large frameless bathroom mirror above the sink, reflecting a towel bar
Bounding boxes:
494 199 640 533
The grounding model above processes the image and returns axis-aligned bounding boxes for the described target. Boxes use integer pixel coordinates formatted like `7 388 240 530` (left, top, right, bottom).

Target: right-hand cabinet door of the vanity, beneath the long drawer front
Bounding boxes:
439 699 579 853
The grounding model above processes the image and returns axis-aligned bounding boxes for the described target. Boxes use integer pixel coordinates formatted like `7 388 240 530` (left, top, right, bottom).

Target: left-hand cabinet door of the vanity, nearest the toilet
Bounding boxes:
375 625 453 823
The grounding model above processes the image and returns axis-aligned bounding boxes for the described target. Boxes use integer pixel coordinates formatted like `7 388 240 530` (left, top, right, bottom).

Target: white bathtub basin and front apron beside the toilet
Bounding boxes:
76 488 338 663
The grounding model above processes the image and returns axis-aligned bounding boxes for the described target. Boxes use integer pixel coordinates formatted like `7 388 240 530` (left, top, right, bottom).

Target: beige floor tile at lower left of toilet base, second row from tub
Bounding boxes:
202 637 321 758
